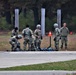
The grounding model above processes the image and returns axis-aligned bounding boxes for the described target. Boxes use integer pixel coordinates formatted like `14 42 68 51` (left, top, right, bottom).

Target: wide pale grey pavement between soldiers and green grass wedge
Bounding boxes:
0 51 76 68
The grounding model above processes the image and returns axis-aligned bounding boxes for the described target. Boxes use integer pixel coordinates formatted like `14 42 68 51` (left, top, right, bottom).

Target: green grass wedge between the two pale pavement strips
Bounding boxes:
0 60 76 71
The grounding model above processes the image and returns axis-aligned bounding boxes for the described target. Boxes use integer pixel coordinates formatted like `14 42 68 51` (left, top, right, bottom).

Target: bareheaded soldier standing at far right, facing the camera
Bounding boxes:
60 23 69 49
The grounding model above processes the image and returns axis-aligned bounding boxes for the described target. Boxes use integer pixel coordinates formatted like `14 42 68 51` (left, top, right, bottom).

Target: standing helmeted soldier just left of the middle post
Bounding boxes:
34 24 42 50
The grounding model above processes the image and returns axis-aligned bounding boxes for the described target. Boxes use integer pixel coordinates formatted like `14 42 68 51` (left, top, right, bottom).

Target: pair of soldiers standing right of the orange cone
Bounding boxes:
54 23 69 51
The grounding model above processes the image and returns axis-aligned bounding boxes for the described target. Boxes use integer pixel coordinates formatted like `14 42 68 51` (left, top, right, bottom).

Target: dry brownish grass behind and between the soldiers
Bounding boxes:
0 32 76 51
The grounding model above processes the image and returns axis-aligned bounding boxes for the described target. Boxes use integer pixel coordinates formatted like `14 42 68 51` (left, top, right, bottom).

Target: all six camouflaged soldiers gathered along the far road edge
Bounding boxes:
9 23 69 51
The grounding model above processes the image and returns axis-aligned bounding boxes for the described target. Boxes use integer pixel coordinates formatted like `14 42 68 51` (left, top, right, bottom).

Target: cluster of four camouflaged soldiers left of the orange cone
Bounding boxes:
9 24 42 51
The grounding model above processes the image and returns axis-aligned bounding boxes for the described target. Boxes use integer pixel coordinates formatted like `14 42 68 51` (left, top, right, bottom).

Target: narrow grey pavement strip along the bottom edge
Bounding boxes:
0 71 76 75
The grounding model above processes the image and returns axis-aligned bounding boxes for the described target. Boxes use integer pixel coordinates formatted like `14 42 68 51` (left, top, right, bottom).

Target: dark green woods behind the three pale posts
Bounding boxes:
0 0 76 32
